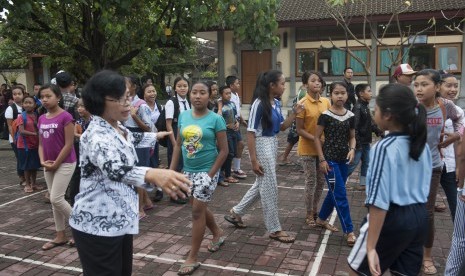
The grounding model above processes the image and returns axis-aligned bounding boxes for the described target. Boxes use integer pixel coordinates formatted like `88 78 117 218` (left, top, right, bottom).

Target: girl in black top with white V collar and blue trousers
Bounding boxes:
314 82 356 246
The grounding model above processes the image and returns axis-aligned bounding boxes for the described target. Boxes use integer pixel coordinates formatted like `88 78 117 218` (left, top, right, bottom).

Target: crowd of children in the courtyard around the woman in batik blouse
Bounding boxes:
5 66 465 275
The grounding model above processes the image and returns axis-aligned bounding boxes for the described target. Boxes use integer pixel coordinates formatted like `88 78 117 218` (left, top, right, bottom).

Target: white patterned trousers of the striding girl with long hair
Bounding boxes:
233 137 282 233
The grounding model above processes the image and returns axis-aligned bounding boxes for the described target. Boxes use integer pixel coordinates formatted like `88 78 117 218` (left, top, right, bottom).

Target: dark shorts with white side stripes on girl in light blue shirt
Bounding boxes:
347 203 428 275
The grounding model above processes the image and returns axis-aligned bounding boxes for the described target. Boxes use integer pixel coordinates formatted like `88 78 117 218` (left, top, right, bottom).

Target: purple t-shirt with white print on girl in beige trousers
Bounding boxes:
37 111 76 163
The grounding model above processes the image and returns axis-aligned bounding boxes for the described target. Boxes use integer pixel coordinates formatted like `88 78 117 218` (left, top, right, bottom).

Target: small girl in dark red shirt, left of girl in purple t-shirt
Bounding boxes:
16 96 41 193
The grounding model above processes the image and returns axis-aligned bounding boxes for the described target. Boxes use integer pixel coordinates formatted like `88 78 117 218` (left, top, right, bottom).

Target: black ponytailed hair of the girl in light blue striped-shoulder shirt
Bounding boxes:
376 83 427 161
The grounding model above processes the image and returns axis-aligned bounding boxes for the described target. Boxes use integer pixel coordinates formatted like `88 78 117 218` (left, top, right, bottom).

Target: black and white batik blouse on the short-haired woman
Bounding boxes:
69 116 157 237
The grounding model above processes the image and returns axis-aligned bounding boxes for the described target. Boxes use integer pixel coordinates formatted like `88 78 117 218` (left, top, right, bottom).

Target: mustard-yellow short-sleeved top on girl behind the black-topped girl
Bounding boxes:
296 93 331 156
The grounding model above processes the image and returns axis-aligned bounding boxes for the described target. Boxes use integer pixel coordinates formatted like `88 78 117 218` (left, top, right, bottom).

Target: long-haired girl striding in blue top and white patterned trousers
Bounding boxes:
224 70 303 243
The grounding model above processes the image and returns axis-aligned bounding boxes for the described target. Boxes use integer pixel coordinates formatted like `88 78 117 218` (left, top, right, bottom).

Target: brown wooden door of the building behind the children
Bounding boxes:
240 50 271 104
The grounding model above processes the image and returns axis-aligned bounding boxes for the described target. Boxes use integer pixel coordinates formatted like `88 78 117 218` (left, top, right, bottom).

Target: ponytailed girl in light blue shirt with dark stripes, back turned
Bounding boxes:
348 84 432 275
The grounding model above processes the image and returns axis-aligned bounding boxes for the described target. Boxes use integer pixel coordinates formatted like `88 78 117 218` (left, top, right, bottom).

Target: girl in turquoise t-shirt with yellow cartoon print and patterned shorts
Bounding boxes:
170 83 228 275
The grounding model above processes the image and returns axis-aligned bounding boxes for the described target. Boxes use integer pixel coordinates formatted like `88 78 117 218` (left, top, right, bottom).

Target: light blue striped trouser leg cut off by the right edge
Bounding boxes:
444 194 465 276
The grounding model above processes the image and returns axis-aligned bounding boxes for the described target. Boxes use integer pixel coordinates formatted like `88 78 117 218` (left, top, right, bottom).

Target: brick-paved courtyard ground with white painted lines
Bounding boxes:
0 134 452 276
